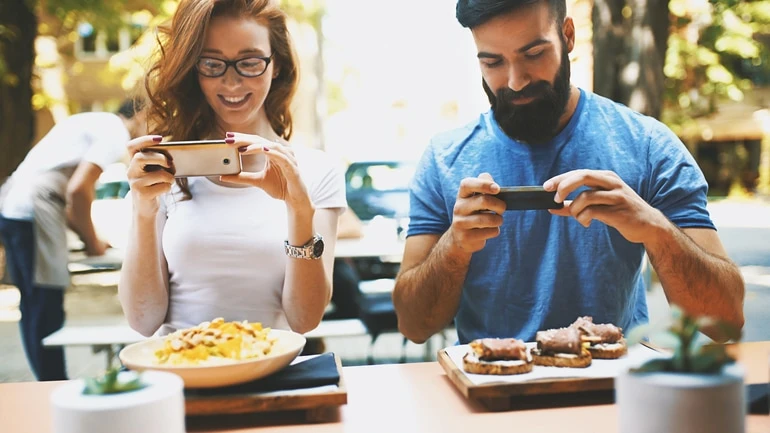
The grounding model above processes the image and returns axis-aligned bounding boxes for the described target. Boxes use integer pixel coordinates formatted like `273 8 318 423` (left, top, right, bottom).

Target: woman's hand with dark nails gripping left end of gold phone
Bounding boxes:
126 135 174 216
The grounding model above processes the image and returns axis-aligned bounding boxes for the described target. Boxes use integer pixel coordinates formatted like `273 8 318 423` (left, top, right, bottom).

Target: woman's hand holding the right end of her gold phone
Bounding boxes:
220 132 311 209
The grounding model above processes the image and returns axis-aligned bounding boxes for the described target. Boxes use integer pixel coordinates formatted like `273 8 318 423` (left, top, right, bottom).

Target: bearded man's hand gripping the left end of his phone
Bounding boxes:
449 173 505 254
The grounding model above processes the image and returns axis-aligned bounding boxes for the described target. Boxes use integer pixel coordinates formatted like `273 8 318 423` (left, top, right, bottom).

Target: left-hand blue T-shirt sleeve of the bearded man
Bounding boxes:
407 145 451 236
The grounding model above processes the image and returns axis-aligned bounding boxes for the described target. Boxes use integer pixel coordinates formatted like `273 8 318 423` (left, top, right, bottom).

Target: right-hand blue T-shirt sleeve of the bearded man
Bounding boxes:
647 123 715 229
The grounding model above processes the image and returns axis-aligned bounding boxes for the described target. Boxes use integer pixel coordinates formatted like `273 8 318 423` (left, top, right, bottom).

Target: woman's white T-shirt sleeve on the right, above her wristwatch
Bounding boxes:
302 151 348 214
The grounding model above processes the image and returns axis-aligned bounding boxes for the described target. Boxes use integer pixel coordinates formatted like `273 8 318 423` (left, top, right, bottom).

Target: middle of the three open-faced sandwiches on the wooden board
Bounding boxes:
532 327 591 368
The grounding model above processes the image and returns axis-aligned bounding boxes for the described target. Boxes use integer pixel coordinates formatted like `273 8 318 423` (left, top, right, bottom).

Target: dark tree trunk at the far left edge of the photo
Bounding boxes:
0 0 37 182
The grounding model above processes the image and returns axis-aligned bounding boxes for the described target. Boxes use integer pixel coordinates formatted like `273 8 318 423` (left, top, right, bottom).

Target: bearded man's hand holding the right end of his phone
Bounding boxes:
543 170 670 243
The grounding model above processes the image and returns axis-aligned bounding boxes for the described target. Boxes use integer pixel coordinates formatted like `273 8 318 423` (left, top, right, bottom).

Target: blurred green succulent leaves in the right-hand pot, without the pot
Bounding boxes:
628 305 741 374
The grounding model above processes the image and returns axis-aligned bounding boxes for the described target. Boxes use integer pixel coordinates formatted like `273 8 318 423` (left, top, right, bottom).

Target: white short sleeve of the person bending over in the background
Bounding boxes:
83 116 131 170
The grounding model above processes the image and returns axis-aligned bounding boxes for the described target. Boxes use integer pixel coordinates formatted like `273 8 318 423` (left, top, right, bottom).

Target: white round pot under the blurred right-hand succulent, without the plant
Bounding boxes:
615 364 746 433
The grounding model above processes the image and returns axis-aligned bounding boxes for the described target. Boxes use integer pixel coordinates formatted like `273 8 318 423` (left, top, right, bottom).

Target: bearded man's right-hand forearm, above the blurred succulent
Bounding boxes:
645 224 745 327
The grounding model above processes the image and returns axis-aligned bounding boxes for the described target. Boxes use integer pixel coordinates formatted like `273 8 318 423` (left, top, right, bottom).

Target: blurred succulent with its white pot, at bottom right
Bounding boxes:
615 305 746 433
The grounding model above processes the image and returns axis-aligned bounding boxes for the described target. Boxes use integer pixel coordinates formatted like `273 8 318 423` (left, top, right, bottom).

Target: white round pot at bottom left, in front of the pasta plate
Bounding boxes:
51 371 185 433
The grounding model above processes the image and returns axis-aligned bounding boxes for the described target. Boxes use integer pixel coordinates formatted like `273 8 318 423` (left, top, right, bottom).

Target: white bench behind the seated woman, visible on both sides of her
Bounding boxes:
43 319 369 369
